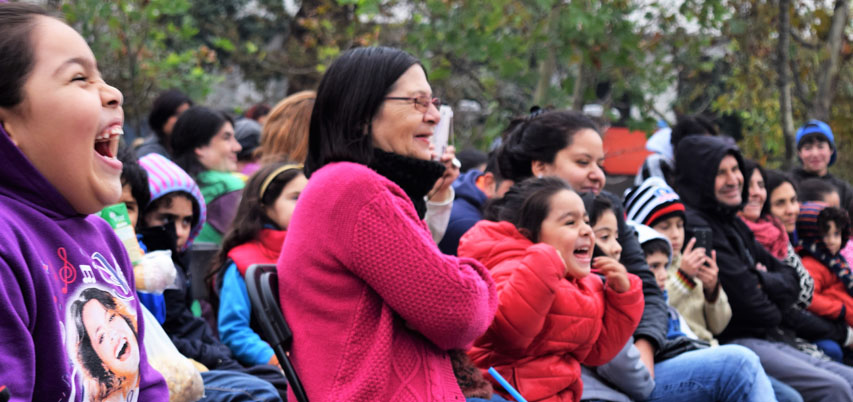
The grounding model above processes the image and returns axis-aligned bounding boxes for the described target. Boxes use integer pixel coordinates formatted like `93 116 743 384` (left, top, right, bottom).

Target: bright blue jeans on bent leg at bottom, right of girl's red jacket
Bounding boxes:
648 345 776 402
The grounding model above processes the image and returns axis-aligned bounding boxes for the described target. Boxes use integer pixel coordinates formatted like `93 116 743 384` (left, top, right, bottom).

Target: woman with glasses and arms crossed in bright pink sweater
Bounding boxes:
278 48 497 401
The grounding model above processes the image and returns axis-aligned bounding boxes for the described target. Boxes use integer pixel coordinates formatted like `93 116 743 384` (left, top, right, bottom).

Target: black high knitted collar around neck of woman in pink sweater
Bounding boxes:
367 148 446 219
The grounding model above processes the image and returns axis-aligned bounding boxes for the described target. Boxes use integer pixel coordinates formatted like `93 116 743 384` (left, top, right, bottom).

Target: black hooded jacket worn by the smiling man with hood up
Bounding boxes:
675 136 799 342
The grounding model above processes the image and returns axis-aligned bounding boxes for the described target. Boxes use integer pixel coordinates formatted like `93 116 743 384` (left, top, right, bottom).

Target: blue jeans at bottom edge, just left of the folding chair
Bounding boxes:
201 370 281 402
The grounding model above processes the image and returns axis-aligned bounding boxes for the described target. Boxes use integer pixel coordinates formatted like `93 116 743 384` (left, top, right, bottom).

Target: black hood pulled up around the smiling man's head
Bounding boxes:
675 136 749 216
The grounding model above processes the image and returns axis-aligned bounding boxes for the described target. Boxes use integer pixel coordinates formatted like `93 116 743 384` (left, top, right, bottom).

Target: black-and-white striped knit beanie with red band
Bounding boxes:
625 177 685 226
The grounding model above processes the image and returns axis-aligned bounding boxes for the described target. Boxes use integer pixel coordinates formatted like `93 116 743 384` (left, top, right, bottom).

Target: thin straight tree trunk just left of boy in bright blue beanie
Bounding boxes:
776 0 796 170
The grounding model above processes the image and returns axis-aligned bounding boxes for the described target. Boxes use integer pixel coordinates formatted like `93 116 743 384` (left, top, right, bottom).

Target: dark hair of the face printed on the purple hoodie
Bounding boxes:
70 287 139 399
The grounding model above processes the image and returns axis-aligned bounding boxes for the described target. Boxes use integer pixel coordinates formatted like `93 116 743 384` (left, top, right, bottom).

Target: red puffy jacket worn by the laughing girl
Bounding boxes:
459 221 644 401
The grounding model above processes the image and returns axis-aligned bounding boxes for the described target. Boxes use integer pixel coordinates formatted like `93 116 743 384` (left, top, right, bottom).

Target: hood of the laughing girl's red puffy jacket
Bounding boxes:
459 221 533 269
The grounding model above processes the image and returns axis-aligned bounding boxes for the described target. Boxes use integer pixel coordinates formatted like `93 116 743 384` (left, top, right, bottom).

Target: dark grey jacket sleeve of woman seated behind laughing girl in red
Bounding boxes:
601 191 669 355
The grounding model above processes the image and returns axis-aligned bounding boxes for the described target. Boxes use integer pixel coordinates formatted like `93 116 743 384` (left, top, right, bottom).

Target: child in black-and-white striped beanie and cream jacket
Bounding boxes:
625 177 732 344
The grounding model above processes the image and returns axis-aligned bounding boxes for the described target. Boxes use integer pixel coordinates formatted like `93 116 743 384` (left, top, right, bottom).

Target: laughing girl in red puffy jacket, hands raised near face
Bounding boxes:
459 178 643 401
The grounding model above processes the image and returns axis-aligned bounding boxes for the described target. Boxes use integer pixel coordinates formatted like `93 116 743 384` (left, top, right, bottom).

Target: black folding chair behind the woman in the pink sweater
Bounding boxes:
246 264 308 402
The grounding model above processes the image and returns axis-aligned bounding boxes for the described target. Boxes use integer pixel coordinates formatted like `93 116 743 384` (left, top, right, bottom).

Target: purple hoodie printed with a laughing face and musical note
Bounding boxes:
0 127 169 402
